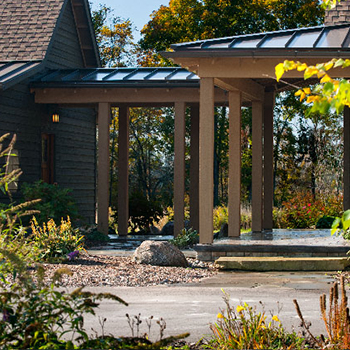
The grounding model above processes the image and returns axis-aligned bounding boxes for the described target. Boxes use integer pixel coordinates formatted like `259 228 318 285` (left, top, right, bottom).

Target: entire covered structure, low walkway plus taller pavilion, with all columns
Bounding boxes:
32 25 350 244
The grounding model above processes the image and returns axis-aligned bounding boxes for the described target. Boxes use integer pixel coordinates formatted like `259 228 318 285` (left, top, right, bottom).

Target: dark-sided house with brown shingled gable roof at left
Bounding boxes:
0 0 100 223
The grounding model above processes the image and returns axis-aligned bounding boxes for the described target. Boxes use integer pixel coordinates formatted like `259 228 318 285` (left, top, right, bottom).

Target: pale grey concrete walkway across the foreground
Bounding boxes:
81 272 333 341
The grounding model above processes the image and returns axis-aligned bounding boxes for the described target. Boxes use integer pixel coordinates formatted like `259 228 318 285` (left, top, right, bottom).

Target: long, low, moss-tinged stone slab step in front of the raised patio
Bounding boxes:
215 257 350 271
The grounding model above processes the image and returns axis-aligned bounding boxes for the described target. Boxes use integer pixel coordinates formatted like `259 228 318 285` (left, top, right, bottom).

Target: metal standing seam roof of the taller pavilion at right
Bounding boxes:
164 24 350 57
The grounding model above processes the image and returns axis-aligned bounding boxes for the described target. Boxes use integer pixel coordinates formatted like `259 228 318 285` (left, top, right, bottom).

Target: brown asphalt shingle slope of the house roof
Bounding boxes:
0 0 65 61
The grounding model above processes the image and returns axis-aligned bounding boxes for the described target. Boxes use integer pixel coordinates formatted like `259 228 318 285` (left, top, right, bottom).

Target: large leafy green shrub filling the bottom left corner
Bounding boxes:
0 251 127 349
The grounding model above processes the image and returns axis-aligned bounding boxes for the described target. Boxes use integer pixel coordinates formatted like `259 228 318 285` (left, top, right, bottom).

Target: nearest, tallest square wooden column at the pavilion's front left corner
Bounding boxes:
198 78 214 244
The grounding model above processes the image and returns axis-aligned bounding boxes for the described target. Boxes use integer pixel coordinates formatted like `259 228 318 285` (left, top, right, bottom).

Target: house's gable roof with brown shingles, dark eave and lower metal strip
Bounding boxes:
0 0 100 89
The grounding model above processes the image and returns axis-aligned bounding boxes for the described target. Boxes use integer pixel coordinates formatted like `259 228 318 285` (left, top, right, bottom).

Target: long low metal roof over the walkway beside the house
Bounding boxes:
31 67 199 88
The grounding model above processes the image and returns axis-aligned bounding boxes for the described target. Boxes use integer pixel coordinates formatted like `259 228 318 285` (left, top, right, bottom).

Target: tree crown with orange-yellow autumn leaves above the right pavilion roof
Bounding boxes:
140 0 324 52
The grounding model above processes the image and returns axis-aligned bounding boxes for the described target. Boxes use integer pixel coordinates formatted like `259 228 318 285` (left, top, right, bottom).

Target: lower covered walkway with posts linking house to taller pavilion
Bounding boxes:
32 68 228 236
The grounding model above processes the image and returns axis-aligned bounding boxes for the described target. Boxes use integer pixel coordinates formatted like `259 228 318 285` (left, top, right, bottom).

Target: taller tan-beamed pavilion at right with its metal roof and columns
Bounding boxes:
164 24 350 243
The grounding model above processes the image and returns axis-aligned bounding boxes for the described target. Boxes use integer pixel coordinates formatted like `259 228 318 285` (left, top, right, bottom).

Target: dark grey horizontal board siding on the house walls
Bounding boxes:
0 2 96 224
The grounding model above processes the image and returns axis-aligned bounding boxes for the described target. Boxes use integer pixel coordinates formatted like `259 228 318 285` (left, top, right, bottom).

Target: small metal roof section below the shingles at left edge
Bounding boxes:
0 61 41 89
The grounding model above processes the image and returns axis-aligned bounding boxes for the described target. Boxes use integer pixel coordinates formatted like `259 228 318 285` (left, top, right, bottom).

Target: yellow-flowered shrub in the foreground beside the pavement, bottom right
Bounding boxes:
210 293 305 349
